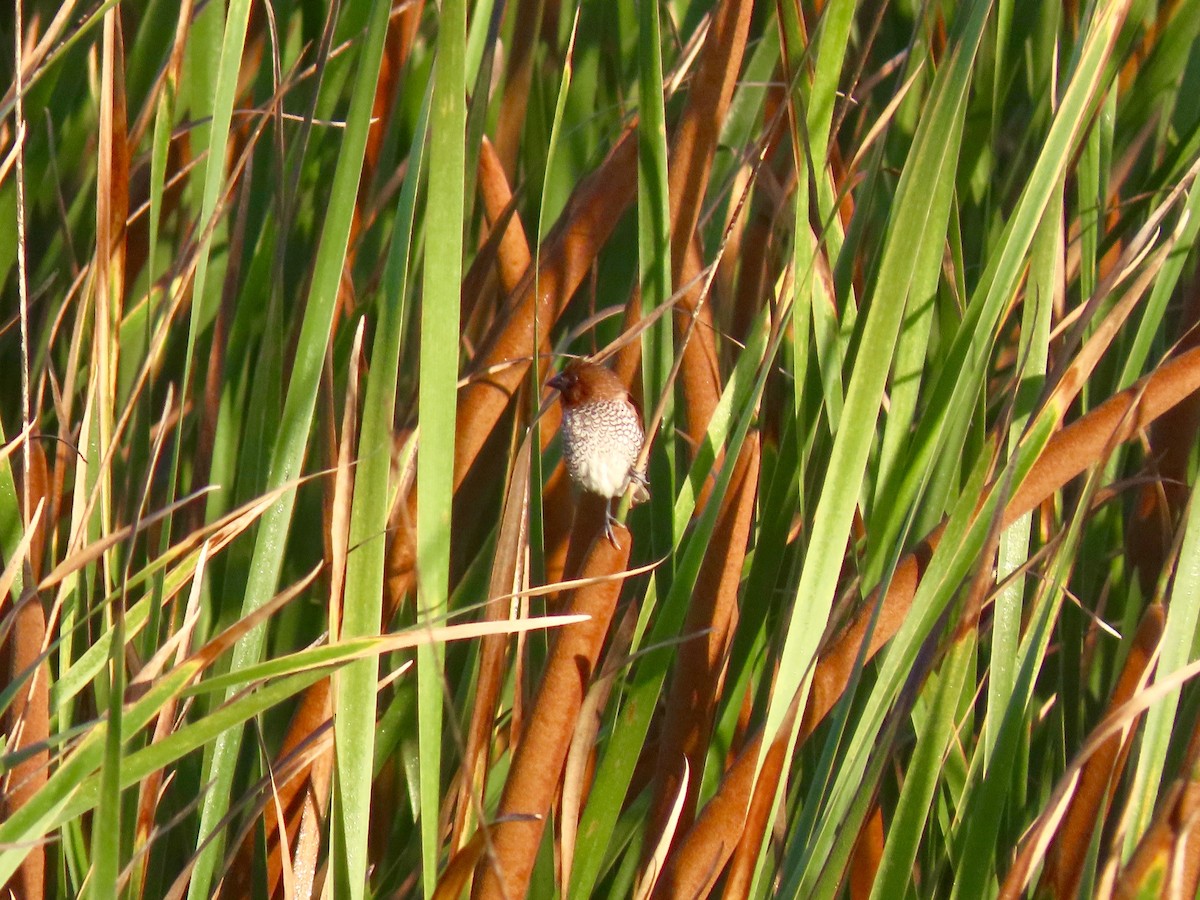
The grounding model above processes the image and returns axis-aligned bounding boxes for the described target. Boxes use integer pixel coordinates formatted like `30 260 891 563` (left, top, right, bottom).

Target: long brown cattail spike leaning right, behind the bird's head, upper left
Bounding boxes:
384 127 637 618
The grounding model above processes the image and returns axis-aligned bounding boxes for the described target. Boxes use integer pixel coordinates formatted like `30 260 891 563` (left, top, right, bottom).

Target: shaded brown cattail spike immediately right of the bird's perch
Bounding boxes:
647 433 760 835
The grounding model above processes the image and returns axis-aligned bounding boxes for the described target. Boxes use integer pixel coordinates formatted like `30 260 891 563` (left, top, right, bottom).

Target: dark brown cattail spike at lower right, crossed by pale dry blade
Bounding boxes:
1032 604 1165 898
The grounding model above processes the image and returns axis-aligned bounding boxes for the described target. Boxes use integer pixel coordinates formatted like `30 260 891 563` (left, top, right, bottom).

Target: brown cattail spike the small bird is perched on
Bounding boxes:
472 529 632 900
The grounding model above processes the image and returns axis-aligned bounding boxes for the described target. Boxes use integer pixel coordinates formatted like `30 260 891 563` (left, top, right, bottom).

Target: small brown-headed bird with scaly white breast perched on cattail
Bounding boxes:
547 362 650 546
